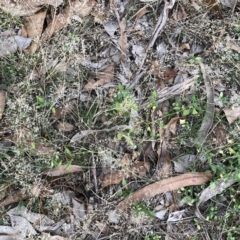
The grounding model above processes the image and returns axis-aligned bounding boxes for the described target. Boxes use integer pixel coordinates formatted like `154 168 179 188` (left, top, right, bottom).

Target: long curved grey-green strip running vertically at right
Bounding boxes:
193 63 214 147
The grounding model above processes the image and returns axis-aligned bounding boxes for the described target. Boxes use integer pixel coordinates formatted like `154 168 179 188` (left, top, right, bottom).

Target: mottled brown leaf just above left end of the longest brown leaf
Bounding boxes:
102 161 150 188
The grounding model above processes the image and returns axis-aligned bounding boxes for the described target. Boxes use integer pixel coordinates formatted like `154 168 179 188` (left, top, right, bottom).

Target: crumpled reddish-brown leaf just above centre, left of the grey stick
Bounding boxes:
83 65 115 91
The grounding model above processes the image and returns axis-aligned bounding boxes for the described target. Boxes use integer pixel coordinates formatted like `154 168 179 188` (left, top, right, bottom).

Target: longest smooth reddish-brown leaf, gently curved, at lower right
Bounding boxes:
117 172 213 211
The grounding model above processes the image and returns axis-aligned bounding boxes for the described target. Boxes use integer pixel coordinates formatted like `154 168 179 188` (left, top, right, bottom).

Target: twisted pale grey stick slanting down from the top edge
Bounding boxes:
127 0 176 89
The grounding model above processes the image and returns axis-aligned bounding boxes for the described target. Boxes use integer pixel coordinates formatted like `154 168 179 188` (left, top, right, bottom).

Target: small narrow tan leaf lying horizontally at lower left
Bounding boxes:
43 165 83 177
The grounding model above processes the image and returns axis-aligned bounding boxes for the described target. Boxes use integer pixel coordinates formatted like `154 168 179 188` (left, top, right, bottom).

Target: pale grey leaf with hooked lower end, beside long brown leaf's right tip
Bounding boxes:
196 177 236 220
